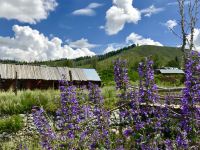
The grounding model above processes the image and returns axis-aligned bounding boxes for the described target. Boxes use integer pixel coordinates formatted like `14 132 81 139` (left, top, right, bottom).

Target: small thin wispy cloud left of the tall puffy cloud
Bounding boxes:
72 3 102 16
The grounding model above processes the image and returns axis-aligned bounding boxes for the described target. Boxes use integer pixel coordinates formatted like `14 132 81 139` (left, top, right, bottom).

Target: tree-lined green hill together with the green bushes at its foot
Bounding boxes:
32 45 182 84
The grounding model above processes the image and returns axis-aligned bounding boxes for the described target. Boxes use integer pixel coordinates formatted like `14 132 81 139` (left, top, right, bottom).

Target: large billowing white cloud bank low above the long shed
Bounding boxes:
0 25 95 61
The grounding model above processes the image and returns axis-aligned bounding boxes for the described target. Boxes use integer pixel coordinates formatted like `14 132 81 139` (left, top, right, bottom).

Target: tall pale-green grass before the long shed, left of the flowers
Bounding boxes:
0 89 60 115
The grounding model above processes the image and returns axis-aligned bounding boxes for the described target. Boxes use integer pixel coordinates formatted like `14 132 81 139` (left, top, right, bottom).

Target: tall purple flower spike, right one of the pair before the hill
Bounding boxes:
136 58 162 149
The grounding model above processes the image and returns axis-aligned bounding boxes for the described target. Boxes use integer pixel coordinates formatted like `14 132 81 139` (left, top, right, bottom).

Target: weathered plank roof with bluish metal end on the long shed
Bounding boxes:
0 64 101 81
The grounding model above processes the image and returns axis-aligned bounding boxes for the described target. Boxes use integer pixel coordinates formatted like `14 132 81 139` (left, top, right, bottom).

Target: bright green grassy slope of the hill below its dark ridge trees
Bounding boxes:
75 46 182 70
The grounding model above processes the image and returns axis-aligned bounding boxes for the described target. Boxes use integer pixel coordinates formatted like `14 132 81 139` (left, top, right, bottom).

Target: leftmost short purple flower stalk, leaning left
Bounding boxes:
32 107 56 150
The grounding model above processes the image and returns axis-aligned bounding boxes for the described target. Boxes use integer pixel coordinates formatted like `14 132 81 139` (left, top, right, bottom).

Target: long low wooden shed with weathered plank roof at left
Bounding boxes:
0 64 101 91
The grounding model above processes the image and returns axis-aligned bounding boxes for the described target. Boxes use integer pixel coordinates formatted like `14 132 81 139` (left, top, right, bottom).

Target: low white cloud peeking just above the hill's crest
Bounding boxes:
126 33 163 46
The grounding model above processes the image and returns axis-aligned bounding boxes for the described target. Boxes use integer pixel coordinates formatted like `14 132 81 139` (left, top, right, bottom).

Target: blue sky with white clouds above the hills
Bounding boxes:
0 0 200 61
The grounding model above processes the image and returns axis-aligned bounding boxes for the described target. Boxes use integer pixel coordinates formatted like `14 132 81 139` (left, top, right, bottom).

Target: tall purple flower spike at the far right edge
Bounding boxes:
177 51 200 147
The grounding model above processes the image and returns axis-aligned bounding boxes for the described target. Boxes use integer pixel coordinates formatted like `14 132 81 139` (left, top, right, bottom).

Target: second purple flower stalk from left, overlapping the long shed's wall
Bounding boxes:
56 81 84 148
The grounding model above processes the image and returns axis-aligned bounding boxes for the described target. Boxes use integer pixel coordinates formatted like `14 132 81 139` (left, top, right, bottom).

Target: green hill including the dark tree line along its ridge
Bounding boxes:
28 45 182 70
